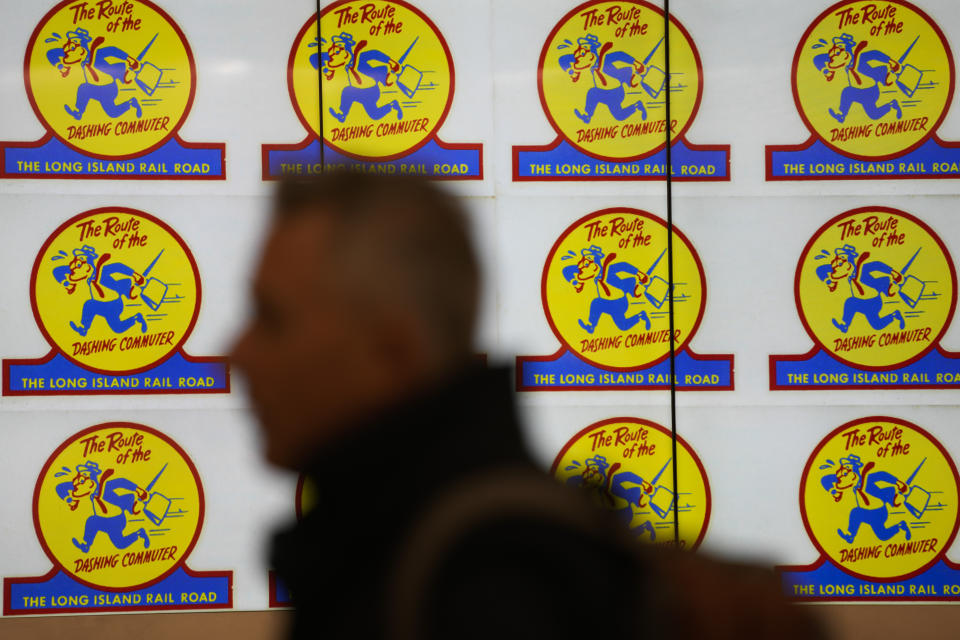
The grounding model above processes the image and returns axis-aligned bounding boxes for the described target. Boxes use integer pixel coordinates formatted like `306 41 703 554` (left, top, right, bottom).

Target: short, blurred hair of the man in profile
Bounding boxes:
276 171 479 368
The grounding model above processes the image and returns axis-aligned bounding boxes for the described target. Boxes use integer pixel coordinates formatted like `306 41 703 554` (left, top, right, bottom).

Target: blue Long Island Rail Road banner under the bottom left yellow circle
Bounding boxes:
3 567 233 615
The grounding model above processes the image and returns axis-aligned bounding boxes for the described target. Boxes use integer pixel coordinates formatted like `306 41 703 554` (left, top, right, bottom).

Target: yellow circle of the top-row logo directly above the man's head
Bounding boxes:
288 0 454 160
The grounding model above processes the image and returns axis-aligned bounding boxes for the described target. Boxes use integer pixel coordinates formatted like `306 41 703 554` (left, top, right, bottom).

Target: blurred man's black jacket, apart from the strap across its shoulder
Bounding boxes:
273 370 638 640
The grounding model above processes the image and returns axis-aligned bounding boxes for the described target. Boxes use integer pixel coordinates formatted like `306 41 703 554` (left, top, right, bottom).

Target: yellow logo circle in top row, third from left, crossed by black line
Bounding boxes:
537 0 703 161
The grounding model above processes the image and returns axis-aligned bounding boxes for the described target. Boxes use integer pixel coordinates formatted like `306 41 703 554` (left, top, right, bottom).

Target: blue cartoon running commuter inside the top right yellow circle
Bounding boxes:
813 33 903 122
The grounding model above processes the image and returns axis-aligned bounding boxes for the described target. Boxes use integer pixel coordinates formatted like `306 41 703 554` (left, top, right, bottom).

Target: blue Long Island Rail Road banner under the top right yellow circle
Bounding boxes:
767 136 960 180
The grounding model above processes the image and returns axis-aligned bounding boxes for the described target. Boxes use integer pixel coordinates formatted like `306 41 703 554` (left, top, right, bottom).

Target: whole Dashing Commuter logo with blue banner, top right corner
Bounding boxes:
767 0 960 180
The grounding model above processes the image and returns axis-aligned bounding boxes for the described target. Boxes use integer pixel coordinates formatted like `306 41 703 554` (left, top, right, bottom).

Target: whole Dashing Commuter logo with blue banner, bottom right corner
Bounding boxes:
777 416 960 601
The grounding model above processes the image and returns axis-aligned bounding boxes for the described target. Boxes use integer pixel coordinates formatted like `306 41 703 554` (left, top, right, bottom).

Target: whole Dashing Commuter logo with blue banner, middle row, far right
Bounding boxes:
770 207 960 390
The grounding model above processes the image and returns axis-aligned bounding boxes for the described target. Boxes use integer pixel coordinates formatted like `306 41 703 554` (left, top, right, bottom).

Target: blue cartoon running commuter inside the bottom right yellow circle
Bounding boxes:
820 455 910 544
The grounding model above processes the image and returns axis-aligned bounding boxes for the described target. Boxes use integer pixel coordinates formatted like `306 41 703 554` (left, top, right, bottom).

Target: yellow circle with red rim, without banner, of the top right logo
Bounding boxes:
793 0 953 160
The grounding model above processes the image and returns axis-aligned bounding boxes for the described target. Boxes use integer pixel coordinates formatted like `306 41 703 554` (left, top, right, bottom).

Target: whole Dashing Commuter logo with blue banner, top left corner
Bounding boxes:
0 0 225 180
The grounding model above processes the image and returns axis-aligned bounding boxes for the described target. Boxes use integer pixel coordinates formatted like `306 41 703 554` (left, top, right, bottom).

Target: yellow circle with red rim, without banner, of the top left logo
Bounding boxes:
25 0 196 159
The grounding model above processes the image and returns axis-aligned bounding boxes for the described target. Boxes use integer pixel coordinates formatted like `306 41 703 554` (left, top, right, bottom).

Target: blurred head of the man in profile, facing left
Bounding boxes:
233 173 479 468
